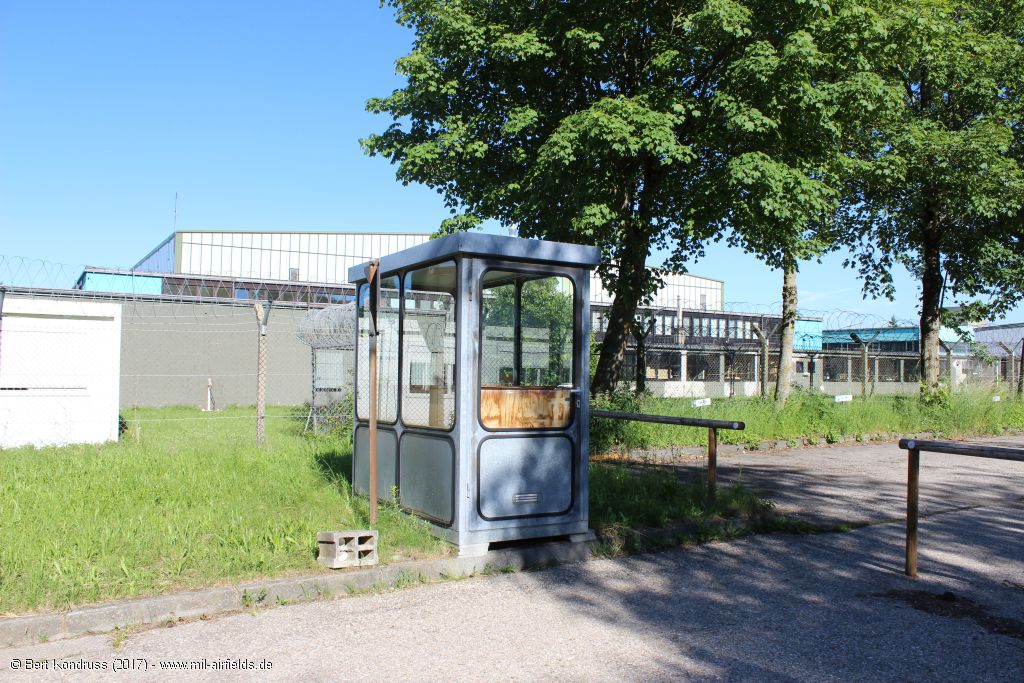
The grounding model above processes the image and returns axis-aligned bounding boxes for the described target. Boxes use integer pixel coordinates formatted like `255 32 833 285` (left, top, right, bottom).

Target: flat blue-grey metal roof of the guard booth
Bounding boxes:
348 232 601 284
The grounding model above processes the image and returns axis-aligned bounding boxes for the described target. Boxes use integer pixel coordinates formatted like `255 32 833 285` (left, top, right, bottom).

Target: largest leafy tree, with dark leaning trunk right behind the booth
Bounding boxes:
364 0 888 392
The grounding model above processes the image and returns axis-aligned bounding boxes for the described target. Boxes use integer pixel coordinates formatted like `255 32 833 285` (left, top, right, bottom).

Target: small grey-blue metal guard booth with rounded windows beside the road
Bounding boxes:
348 232 599 555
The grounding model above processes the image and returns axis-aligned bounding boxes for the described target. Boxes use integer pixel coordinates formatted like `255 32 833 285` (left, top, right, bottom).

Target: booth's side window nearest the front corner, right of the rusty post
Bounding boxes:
401 261 458 429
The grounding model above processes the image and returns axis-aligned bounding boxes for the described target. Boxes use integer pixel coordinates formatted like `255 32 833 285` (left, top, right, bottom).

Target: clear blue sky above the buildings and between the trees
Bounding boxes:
0 0 1007 323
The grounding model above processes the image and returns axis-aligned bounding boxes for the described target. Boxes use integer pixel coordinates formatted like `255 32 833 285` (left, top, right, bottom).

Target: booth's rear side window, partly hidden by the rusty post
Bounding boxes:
355 275 398 423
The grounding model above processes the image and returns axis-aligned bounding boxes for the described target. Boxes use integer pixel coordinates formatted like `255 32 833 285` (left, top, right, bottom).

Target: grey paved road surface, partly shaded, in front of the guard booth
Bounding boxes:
0 445 1024 683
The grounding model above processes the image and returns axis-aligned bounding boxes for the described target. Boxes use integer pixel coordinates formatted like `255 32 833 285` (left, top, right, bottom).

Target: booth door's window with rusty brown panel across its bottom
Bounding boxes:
480 270 575 429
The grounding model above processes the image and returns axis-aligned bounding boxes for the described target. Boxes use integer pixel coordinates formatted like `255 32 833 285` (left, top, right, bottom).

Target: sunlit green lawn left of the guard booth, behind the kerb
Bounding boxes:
0 408 449 613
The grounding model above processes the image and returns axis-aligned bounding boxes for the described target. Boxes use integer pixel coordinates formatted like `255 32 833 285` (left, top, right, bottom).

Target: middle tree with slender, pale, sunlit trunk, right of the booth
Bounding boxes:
667 2 887 402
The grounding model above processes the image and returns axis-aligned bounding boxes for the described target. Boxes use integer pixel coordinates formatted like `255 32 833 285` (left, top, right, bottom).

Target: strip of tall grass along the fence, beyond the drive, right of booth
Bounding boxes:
592 391 1024 449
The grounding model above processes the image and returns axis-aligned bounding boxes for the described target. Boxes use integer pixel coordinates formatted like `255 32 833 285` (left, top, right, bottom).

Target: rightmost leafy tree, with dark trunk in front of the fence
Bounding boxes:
844 0 1024 393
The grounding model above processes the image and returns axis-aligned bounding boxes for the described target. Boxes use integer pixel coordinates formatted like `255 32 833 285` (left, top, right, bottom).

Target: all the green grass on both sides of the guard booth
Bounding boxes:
9 392 1024 614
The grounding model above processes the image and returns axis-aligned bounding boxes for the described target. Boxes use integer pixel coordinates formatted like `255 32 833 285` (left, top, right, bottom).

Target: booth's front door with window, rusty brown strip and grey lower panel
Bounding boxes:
477 269 582 520
